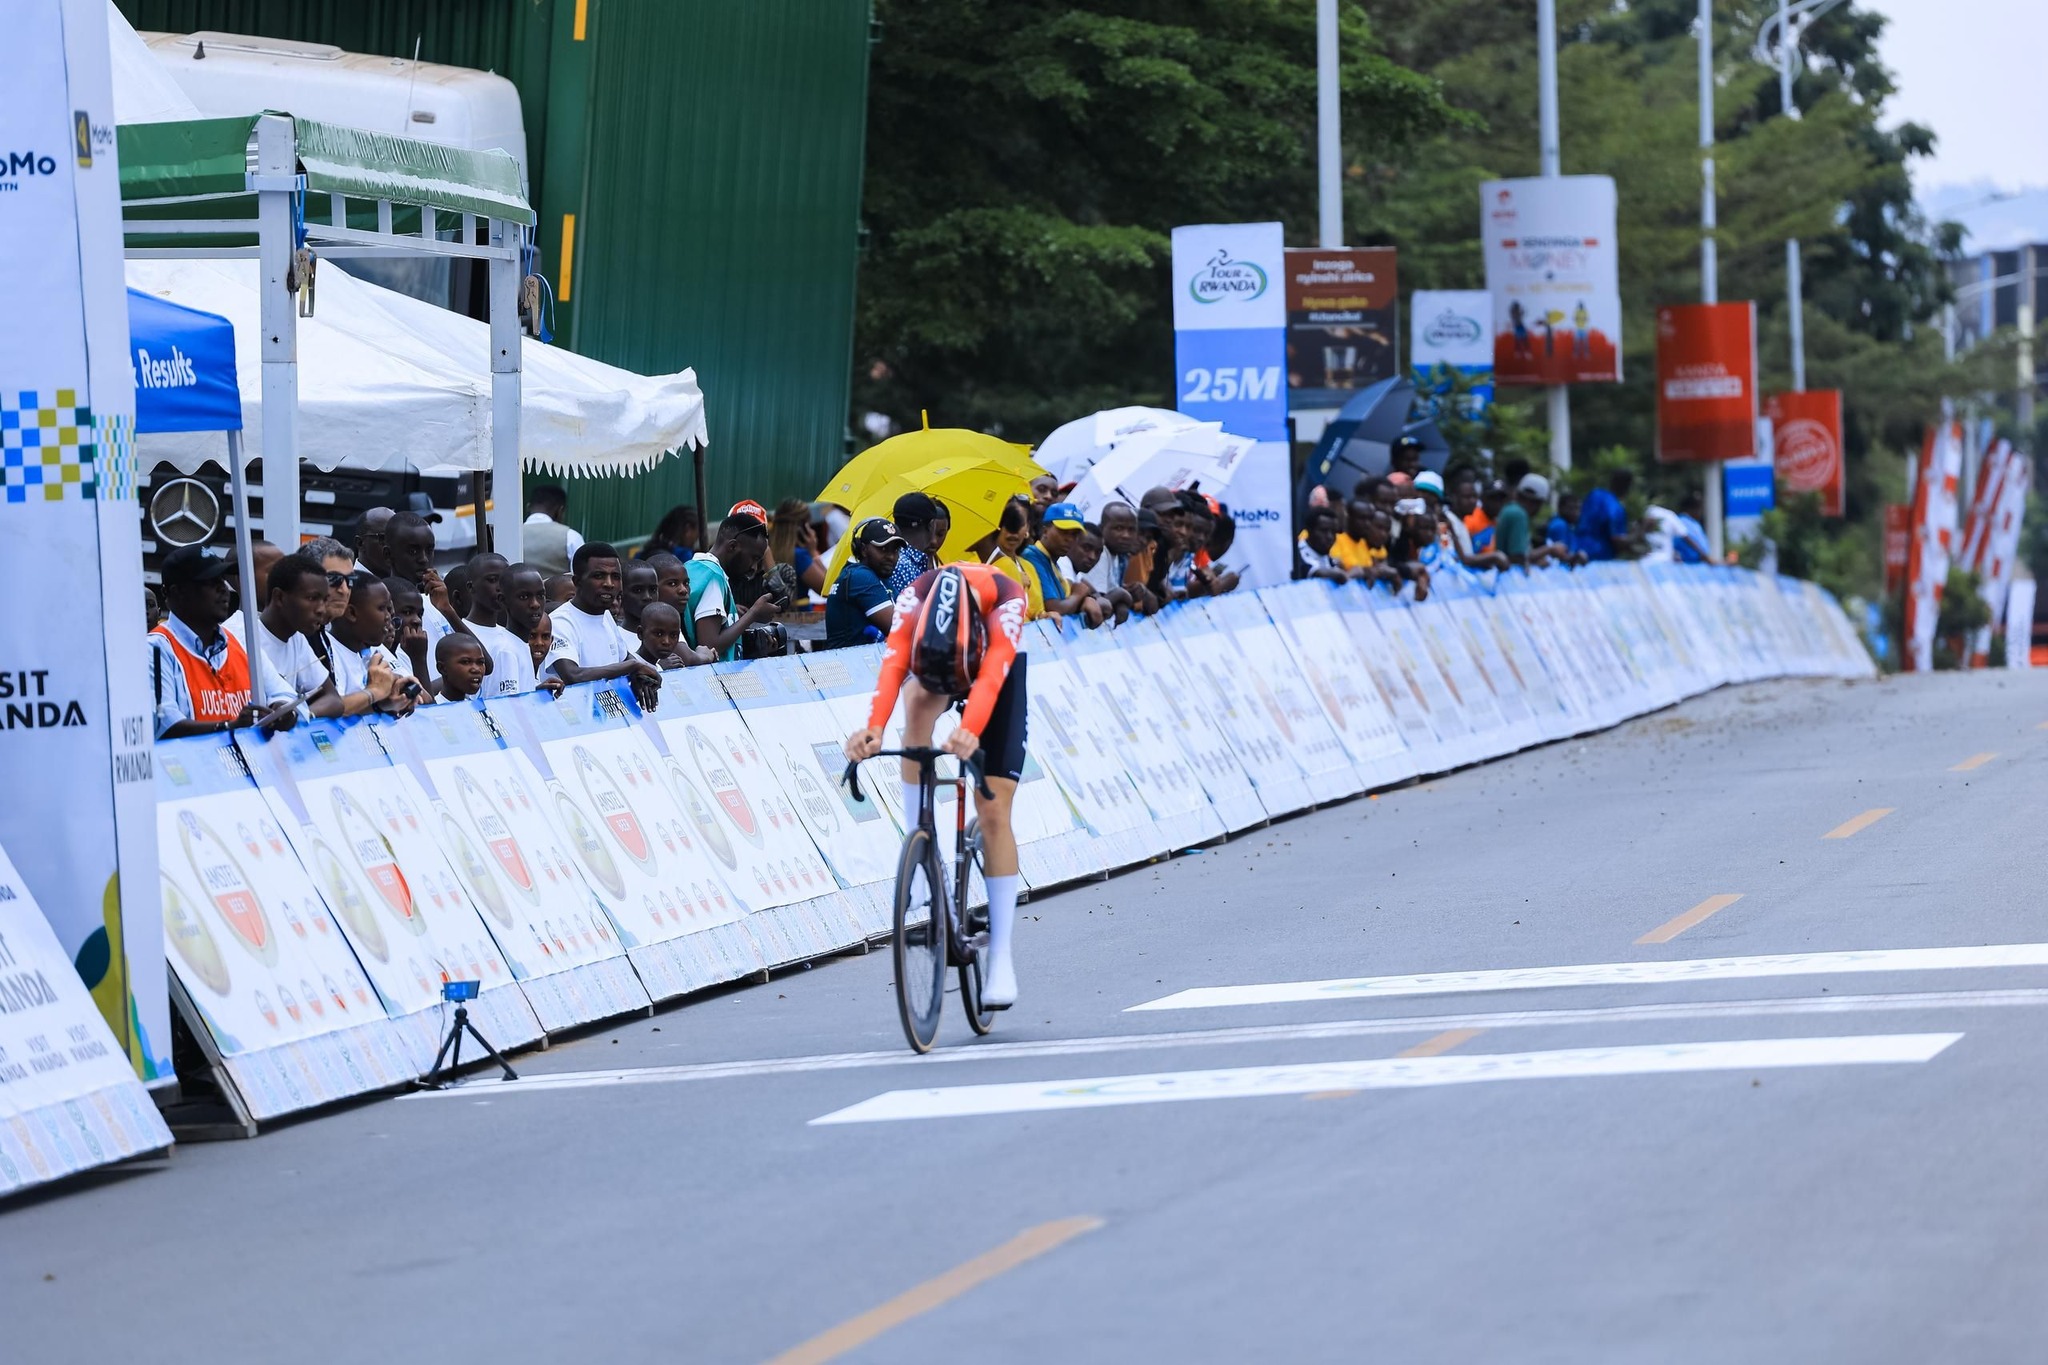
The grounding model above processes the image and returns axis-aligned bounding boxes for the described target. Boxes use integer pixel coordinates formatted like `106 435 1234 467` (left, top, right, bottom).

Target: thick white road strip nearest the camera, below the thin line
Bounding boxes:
811 1033 1962 1126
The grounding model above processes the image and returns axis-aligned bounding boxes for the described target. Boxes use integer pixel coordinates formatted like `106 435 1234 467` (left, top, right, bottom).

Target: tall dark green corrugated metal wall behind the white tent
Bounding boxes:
117 0 868 536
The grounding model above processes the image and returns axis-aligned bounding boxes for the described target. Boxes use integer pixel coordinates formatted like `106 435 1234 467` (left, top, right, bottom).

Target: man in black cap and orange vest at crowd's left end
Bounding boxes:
150 544 299 739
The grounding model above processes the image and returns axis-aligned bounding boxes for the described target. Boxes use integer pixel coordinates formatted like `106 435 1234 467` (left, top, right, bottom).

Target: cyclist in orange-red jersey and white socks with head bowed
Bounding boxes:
846 565 1026 1009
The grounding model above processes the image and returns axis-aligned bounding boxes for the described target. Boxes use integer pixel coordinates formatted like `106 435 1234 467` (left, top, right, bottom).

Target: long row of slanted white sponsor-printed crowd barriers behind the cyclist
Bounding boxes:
12 565 1872 1178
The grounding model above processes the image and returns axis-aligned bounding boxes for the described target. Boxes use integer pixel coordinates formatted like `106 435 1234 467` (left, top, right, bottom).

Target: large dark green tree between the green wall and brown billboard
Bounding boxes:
854 0 1470 438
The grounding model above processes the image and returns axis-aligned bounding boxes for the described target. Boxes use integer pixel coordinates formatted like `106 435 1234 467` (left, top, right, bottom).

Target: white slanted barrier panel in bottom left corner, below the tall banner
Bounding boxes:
0 849 170 1193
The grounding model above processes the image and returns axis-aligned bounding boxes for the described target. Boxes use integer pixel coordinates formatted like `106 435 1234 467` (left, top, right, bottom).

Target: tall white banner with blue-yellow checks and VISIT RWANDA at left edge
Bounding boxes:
0 0 170 1081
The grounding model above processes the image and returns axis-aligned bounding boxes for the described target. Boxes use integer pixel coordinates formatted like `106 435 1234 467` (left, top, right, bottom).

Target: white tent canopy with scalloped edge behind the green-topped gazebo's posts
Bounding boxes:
127 260 705 475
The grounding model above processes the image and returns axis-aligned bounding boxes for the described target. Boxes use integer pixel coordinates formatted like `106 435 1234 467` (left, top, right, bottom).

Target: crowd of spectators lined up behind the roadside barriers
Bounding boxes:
147 450 1708 739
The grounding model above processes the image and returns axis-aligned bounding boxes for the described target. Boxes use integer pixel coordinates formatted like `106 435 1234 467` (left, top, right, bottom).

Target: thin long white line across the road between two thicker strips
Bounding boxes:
399 988 2048 1099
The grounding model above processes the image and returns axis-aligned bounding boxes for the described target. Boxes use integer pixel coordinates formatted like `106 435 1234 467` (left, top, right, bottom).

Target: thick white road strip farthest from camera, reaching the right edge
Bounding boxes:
1126 943 2048 1013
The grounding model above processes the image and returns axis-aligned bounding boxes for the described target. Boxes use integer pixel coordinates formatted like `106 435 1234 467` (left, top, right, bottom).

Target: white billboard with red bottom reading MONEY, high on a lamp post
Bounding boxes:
1479 176 1622 385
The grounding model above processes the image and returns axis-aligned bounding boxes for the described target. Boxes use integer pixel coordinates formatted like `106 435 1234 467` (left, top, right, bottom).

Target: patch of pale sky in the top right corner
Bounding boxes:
1862 0 2048 196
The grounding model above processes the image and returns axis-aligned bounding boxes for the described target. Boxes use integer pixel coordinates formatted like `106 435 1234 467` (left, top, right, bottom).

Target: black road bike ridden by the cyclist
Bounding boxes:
846 747 995 1052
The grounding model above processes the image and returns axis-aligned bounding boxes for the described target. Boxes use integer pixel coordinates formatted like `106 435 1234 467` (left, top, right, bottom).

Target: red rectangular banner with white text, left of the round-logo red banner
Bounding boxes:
1657 303 1757 465
